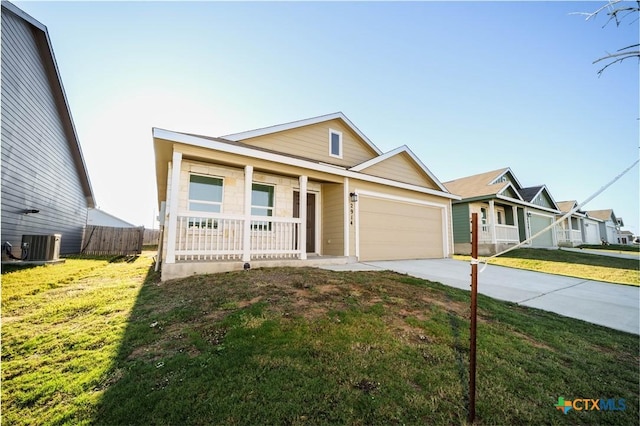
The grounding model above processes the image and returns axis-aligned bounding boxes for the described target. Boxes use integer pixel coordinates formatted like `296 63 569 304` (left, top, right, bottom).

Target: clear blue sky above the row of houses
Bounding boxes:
15 1 640 234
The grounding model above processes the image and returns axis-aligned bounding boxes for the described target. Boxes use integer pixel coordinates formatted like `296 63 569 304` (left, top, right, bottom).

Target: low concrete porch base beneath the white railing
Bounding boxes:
161 254 357 281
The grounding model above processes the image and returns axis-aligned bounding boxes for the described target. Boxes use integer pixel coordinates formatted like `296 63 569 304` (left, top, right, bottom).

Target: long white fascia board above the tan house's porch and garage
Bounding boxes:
153 128 460 200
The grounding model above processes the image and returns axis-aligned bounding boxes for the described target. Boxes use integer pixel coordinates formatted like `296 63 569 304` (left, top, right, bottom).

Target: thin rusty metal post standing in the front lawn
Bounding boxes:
468 213 478 423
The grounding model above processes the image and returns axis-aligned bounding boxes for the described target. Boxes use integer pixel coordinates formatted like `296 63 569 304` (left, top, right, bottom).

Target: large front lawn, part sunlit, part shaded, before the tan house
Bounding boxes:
2 256 640 425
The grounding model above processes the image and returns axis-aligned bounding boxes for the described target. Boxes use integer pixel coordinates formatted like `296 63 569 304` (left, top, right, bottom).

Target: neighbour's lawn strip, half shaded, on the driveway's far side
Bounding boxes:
454 248 640 286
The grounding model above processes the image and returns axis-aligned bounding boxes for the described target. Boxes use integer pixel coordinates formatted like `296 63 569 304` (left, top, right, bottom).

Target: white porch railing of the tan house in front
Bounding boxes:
175 213 302 261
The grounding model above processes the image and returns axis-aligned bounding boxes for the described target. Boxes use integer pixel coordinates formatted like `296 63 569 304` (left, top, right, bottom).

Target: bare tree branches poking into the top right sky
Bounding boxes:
575 0 640 76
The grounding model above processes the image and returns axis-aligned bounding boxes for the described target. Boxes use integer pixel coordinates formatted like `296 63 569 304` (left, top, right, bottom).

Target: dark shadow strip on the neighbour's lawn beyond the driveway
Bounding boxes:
500 248 640 271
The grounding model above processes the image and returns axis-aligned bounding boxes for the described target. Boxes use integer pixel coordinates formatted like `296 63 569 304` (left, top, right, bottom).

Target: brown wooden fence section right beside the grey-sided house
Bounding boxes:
82 225 144 256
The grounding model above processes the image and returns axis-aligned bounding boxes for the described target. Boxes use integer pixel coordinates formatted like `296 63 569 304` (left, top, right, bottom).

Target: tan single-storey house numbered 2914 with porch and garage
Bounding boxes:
153 112 459 279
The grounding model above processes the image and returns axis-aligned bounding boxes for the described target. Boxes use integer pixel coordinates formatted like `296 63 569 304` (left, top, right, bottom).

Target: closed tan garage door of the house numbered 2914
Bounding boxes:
358 196 444 260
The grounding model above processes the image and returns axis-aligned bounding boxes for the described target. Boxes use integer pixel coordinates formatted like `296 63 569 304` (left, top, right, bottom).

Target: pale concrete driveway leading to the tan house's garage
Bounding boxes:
322 259 640 334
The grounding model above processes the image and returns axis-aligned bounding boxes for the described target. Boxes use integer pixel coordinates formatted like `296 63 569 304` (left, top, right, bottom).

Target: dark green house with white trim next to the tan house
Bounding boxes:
444 168 560 255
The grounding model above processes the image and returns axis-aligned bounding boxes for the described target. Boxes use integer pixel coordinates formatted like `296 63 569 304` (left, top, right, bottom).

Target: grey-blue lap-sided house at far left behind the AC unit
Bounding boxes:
1 1 95 256
